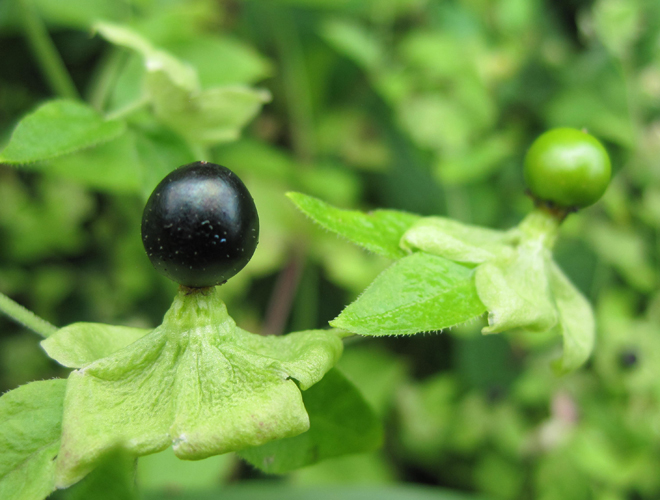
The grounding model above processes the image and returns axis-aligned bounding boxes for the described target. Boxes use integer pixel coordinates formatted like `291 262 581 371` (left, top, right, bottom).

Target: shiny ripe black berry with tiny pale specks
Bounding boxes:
142 162 259 288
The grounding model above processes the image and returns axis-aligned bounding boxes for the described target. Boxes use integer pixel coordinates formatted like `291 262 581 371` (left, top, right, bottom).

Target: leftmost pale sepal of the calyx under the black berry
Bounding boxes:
41 323 151 368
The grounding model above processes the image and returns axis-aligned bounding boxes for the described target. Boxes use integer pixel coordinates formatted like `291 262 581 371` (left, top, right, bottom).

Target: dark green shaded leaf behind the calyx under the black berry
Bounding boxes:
239 369 383 474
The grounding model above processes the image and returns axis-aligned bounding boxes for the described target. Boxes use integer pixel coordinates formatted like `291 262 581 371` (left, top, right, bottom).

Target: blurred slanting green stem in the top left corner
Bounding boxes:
19 0 80 99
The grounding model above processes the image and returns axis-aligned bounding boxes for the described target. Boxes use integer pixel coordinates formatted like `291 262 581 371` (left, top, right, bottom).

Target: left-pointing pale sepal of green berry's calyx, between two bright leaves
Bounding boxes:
401 217 507 264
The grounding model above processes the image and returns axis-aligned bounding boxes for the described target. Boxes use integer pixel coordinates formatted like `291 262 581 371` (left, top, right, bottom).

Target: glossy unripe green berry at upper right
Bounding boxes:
524 128 612 209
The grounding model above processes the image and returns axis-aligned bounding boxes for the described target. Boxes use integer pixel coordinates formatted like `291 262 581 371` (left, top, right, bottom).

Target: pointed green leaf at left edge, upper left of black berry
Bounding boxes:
0 99 125 164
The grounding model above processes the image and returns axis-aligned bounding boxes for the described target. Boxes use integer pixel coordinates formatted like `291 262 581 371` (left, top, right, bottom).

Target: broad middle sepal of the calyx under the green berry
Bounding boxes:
475 239 558 333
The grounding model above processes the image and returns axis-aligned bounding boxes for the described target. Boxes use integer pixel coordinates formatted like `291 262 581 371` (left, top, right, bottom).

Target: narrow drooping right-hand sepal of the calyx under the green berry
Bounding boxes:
549 262 596 373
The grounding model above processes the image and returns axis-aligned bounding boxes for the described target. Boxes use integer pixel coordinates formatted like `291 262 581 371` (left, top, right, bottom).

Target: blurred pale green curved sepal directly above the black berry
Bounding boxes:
147 70 270 145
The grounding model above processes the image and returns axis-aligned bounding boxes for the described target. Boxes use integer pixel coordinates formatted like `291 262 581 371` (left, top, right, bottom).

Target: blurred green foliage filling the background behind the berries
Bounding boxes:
0 0 660 500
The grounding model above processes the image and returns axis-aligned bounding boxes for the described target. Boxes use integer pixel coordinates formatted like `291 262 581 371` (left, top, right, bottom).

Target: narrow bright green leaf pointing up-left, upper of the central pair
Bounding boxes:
287 193 419 259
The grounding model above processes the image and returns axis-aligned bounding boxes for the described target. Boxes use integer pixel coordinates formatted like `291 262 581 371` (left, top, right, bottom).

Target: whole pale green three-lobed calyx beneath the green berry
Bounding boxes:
401 208 595 372
